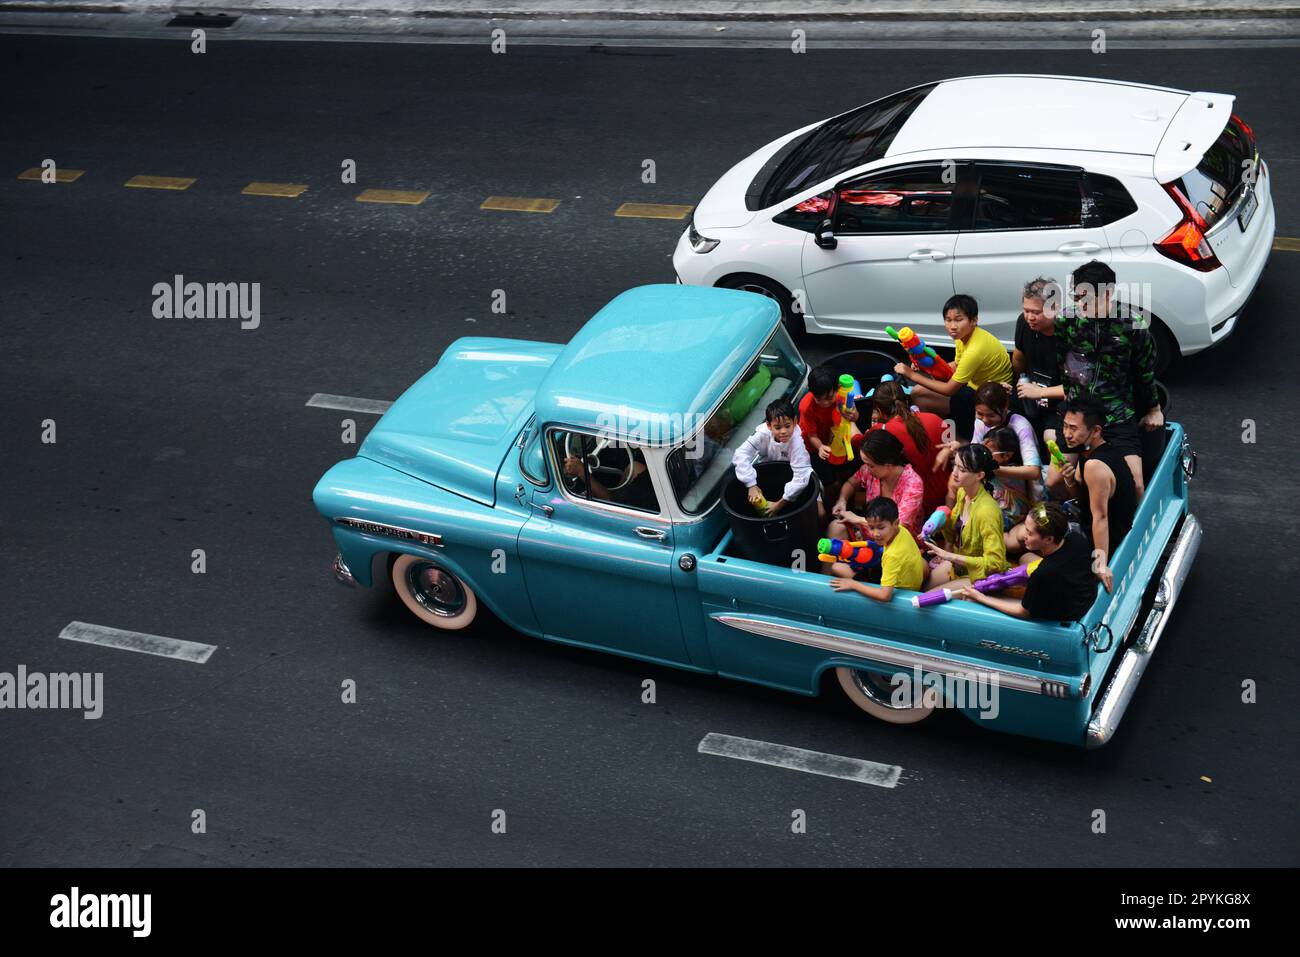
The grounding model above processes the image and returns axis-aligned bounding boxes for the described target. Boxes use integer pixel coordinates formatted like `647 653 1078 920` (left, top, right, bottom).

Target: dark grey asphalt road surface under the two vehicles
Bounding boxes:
0 36 1300 866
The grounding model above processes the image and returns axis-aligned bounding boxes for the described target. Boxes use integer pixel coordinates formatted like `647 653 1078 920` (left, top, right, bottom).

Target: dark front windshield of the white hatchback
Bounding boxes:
762 83 935 207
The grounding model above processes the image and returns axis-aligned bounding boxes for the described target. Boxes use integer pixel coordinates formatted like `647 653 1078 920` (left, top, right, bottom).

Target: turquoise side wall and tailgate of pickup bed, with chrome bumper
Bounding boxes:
698 424 1200 746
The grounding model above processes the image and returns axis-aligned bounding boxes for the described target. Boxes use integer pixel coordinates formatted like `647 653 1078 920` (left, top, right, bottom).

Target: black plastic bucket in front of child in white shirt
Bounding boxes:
723 462 822 567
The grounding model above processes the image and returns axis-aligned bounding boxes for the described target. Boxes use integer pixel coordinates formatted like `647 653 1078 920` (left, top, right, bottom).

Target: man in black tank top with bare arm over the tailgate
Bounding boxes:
1061 395 1138 592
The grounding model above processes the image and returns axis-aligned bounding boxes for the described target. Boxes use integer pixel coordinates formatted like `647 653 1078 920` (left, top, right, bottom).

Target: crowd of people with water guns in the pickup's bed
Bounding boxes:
736 260 1165 620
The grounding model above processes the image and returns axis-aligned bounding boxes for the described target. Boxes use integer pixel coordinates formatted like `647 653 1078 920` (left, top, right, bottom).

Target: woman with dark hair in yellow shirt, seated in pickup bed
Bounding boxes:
926 445 1006 588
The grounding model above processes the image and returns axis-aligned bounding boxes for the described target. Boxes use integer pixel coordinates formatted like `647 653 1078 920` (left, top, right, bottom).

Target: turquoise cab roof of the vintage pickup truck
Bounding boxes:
536 283 781 446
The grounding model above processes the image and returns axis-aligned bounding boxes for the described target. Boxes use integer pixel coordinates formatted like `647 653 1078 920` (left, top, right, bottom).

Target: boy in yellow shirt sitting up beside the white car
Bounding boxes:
894 293 1011 442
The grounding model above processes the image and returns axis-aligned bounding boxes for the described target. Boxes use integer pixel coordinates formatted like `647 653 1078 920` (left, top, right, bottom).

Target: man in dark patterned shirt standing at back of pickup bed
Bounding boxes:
1054 260 1165 499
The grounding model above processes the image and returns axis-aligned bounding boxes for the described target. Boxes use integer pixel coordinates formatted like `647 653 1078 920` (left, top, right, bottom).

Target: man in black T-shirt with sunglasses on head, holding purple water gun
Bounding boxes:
956 502 1097 622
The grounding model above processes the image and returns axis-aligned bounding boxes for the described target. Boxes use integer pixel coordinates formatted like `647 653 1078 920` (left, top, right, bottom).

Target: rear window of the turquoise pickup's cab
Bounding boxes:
668 326 807 515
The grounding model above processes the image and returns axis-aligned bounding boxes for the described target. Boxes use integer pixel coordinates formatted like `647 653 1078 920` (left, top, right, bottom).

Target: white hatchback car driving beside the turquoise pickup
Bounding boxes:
673 75 1274 368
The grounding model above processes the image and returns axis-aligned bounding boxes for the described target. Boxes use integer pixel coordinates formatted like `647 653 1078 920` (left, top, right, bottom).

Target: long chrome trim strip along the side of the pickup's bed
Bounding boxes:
710 612 1083 698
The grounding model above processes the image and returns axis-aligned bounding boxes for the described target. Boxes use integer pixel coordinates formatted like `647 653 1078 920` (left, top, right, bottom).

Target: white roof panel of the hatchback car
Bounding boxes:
885 74 1190 157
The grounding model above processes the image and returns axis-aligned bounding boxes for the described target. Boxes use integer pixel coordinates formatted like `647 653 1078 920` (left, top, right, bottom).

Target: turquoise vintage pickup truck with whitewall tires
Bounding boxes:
313 285 1201 748
